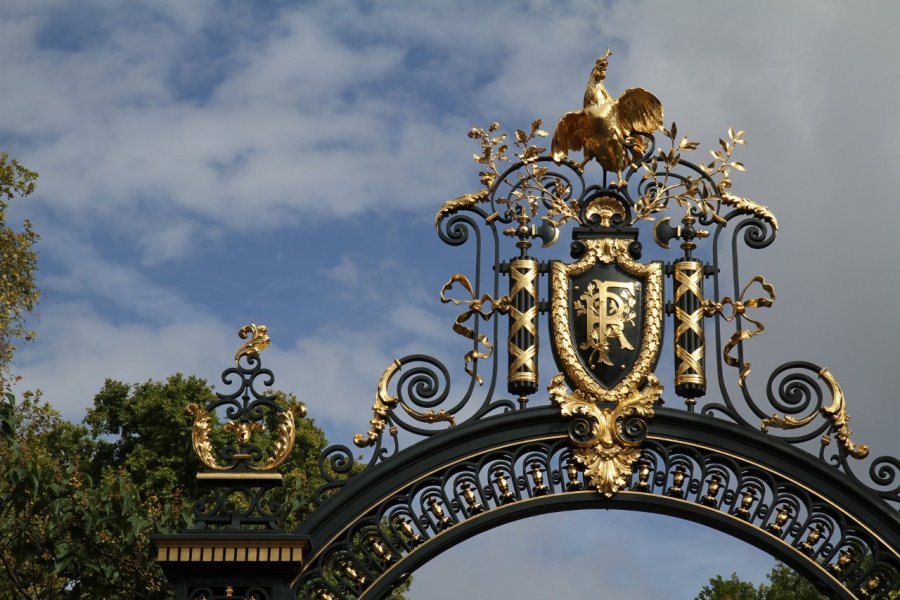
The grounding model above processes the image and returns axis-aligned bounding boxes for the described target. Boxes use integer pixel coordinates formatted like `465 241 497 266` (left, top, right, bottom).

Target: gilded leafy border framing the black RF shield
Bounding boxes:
550 238 663 402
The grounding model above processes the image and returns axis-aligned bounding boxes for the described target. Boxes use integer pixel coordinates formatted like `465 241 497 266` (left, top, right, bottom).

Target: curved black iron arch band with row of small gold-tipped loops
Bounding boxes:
297 407 900 598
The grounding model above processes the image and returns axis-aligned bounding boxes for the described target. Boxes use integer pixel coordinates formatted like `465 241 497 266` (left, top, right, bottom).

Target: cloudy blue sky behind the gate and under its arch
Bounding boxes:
0 0 900 598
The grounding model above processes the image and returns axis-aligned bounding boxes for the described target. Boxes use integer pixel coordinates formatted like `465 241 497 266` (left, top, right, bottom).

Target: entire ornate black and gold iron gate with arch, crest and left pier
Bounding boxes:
155 54 900 600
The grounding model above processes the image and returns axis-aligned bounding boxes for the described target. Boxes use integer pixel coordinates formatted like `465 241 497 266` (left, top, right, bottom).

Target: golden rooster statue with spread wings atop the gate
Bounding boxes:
550 50 663 186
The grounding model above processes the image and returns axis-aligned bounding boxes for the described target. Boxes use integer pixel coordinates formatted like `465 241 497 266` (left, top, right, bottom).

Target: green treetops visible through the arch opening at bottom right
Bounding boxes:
697 563 828 600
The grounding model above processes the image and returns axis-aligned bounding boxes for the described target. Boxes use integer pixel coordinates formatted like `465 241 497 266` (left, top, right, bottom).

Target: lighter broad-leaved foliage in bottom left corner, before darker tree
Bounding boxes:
0 394 188 600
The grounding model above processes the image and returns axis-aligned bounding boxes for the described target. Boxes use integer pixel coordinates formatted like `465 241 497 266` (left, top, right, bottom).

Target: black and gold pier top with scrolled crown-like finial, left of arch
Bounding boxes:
152 323 309 600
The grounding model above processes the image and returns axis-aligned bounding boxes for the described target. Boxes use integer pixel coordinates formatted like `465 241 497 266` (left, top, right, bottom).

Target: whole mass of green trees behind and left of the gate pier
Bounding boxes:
0 375 342 600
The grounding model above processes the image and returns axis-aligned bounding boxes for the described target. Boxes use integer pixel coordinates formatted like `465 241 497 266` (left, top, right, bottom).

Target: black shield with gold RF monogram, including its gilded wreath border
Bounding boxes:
550 238 663 402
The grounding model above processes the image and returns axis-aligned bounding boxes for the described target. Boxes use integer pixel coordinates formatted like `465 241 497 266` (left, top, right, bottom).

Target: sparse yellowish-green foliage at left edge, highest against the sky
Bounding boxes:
0 152 40 389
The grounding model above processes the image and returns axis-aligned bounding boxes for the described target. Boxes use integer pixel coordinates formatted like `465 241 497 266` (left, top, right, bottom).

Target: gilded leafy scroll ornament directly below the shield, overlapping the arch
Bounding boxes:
547 373 663 497
